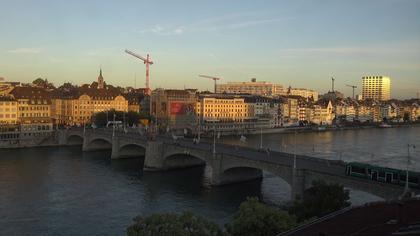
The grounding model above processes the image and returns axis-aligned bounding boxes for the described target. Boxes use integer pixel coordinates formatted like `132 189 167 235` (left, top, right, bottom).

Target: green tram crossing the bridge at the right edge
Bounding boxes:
346 162 420 189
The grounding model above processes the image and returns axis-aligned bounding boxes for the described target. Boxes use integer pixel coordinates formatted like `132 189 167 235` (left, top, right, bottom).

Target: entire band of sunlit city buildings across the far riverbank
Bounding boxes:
0 70 412 136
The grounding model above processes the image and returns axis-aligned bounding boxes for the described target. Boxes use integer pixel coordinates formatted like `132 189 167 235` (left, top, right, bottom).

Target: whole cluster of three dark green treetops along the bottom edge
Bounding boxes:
127 181 350 236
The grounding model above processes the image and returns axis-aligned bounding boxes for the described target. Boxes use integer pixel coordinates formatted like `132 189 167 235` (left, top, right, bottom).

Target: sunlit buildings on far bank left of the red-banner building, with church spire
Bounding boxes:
0 71 148 127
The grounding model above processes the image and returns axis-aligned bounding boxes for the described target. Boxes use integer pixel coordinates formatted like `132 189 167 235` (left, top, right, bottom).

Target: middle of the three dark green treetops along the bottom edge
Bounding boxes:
226 198 296 236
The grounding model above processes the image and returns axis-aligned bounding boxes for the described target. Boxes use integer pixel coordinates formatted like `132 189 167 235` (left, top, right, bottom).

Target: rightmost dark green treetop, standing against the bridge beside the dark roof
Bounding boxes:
289 180 350 222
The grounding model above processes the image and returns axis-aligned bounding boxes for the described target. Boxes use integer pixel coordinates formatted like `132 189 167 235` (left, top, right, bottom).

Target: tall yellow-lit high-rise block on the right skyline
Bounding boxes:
362 76 391 101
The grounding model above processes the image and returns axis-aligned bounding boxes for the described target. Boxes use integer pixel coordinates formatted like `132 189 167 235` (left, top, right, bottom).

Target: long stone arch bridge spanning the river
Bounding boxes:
58 130 420 200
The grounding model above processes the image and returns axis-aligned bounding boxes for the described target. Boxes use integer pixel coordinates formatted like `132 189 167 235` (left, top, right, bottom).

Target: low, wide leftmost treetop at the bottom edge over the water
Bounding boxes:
127 212 223 236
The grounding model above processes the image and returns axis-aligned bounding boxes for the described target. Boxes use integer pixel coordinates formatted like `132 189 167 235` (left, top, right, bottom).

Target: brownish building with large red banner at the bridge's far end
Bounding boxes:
150 89 198 130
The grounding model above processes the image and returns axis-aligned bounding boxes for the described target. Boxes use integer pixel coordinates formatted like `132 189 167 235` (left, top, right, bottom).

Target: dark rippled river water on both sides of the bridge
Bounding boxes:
0 127 420 235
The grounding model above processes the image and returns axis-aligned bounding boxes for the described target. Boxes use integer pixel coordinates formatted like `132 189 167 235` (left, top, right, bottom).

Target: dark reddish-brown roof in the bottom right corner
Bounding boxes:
279 199 420 236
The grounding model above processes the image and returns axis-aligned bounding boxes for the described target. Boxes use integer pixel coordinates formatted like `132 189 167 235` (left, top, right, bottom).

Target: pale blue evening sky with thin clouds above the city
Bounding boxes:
0 0 420 98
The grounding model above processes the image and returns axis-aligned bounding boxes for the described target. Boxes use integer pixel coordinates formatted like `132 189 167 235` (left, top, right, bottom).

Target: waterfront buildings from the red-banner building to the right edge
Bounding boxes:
151 89 420 133
